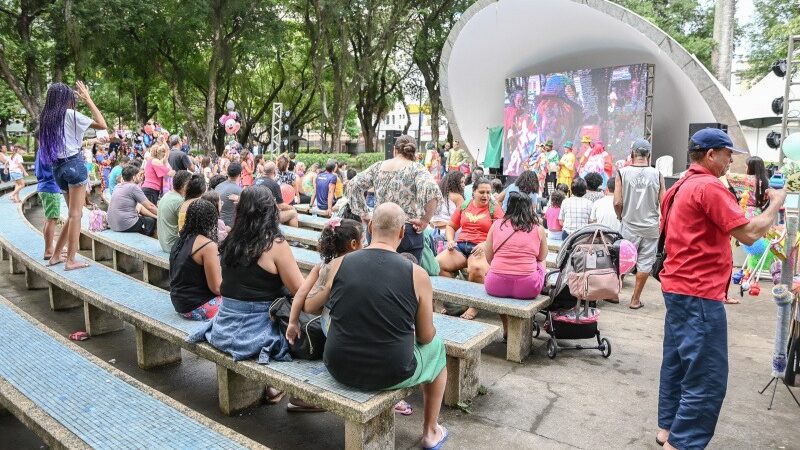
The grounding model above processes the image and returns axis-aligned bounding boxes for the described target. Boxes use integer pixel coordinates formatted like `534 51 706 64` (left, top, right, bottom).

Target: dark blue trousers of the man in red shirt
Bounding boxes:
658 292 728 450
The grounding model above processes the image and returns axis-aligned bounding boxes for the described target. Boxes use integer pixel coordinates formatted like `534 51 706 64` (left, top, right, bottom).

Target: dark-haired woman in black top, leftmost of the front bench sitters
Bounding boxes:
169 199 222 320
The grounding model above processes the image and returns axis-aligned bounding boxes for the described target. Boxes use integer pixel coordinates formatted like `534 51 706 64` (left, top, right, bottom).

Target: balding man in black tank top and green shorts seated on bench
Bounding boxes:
300 202 447 448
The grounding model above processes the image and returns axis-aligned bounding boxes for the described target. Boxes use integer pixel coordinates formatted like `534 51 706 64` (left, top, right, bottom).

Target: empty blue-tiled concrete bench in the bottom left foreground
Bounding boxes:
0 297 265 449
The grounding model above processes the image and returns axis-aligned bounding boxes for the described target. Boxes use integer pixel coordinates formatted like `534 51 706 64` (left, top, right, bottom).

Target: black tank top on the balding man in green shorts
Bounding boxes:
323 249 418 390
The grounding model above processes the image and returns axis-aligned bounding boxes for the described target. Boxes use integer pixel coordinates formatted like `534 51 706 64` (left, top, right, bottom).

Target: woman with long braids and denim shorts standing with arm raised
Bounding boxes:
39 81 107 270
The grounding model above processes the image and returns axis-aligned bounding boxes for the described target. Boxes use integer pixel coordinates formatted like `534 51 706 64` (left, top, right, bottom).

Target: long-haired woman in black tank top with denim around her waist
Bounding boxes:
189 186 303 403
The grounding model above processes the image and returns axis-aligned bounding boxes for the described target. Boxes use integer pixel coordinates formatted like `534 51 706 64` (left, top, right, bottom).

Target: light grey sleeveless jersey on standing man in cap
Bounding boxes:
620 166 661 238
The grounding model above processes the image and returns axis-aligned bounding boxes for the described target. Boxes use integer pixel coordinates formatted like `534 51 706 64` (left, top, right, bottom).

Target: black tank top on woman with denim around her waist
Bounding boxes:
220 255 290 302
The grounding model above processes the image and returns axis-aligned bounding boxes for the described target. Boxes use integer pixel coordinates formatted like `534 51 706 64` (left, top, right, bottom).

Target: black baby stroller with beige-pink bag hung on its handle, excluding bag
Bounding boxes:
535 225 622 359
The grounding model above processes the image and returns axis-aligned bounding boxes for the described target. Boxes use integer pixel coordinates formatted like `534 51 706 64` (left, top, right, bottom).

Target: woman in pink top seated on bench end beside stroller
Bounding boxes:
484 192 547 331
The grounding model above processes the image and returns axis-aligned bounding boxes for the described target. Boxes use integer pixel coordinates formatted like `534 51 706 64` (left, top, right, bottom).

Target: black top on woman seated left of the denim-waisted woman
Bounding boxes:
169 235 216 314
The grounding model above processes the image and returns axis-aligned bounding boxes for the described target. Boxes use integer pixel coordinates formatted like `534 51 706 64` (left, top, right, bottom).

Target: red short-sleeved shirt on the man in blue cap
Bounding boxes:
661 164 749 301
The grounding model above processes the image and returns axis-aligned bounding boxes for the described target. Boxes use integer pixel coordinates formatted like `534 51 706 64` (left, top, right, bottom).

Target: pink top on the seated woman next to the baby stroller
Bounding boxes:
489 219 542 275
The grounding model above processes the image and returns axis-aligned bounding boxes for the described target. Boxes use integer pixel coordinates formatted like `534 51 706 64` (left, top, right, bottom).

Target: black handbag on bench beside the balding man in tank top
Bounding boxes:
269 297 325 360
